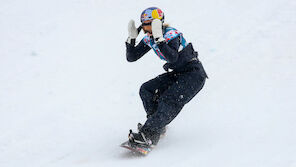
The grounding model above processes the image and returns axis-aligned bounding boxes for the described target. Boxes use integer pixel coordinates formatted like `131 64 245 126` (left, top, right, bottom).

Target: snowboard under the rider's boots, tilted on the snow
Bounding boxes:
120 140 152 155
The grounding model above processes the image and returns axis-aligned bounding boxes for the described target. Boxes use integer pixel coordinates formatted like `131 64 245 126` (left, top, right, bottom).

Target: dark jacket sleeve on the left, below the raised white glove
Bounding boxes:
126 40 151 62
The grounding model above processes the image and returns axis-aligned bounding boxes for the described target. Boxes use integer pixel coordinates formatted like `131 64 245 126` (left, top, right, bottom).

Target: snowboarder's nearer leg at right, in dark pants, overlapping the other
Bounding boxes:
142 71 205 143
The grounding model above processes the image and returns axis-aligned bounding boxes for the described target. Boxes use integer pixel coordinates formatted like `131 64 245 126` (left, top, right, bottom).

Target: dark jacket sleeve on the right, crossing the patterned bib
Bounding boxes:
158 37 180 63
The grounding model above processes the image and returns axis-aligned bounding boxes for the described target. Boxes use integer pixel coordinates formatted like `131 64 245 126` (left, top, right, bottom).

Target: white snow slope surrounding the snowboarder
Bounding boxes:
0 0 296 167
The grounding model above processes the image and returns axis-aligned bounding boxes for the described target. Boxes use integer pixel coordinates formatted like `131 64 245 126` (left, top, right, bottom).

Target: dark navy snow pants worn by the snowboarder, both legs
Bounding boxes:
140 62 207 142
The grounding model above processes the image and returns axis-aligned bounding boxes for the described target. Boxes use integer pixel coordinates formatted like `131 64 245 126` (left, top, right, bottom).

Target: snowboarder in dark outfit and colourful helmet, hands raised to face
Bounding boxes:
126 7 207 147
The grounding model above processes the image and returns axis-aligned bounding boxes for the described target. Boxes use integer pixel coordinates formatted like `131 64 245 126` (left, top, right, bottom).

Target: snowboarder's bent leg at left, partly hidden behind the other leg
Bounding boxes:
140 73 173 117
